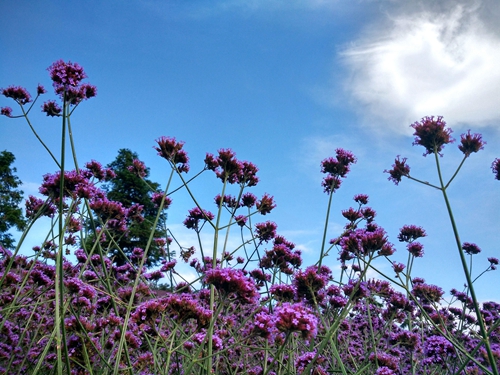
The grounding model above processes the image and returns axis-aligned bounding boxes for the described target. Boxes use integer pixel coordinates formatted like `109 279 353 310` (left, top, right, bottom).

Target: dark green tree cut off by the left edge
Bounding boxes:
0 151 26 249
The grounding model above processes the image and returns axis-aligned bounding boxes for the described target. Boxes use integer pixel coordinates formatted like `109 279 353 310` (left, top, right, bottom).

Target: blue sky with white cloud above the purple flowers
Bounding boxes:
0 0 500 301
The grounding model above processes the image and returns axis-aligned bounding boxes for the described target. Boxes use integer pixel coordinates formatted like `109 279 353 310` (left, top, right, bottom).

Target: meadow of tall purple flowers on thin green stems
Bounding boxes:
0 61 500 375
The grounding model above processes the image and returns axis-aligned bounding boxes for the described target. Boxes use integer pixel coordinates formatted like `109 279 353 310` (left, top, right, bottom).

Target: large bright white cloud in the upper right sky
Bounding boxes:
342 5 500 133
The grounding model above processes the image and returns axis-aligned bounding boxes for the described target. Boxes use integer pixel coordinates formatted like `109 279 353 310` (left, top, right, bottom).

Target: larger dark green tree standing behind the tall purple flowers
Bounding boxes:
100 149 167 267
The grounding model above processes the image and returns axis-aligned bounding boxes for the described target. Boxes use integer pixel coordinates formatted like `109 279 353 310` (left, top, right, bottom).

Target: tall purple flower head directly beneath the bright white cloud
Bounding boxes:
411 116 454 156
